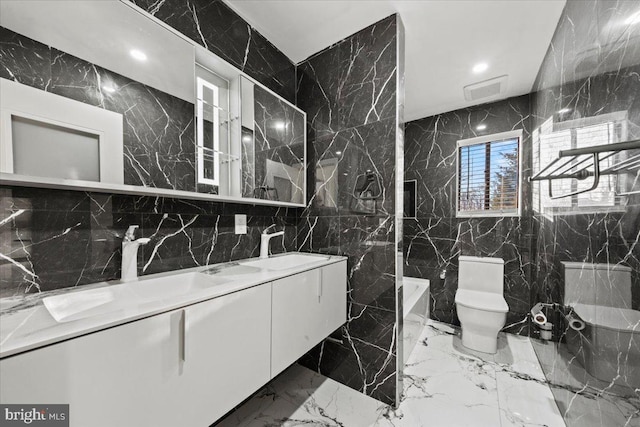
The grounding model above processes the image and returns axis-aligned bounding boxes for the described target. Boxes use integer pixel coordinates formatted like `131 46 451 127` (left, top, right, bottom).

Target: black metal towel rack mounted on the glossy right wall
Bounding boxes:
529 139 640 199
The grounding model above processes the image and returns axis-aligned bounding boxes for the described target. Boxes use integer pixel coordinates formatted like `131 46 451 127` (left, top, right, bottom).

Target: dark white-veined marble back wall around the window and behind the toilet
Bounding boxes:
404 95 534 335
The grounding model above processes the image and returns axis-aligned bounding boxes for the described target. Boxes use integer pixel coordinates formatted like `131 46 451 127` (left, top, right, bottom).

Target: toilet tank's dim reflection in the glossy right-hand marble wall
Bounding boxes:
562 261 631 308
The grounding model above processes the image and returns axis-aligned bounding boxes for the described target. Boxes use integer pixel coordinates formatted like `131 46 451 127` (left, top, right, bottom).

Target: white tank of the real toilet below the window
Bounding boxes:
458 255 504 295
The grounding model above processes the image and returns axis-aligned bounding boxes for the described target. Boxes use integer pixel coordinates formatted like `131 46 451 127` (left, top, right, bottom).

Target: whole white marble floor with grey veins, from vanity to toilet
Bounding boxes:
217 321 565 427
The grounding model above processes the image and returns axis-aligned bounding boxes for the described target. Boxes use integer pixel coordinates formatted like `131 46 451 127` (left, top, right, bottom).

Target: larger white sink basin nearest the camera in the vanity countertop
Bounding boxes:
42 272 230 323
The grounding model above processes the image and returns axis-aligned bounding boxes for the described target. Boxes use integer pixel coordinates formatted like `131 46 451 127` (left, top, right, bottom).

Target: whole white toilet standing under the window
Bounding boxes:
456 256 509 353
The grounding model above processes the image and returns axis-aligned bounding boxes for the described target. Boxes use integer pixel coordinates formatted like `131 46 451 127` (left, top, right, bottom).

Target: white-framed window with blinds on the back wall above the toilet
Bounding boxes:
457 131 522 217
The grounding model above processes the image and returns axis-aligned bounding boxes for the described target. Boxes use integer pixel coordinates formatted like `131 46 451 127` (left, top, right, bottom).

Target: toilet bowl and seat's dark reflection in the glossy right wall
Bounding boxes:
566 304 640 389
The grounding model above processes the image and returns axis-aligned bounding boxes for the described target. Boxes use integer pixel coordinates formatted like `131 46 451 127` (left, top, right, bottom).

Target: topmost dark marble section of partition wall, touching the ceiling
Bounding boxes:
297 15 397 137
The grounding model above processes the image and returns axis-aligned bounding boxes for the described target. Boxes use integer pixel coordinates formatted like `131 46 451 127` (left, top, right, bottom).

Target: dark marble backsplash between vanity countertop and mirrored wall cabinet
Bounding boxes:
0 186 300 297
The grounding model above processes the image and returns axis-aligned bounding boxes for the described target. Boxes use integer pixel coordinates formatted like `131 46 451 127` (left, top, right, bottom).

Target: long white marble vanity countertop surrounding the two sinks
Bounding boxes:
0 253 346 358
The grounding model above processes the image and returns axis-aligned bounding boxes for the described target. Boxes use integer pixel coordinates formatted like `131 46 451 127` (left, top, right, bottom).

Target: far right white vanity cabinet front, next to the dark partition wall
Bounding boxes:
271 261 347 377
